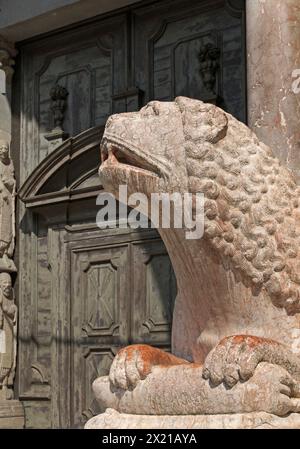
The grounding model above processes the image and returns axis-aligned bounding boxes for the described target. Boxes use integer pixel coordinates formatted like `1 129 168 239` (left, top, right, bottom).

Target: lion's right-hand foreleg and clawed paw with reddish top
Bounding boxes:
203 335 300 388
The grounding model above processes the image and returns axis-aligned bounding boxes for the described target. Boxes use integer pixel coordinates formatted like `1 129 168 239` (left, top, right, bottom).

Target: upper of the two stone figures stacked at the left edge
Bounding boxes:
0 141 16 266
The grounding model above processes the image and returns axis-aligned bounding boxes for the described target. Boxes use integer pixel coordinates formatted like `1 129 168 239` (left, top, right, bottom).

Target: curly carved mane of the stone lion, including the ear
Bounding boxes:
176 97 300 315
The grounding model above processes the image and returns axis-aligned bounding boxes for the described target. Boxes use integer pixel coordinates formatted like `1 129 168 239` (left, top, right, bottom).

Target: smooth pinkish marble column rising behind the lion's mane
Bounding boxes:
246 0 300 182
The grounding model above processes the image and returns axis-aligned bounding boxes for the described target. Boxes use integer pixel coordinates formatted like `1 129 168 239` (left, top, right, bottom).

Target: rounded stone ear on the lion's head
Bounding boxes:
175 97 228 143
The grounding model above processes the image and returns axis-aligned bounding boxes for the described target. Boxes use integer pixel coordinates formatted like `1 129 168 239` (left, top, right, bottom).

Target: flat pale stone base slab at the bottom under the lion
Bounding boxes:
85 409 300 429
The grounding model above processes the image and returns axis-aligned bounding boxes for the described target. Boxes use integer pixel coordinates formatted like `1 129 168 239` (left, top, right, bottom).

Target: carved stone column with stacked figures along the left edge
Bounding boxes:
0 37 24 429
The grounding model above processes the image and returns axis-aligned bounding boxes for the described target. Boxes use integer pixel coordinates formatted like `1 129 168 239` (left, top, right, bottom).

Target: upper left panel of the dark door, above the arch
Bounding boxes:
20 14 126 173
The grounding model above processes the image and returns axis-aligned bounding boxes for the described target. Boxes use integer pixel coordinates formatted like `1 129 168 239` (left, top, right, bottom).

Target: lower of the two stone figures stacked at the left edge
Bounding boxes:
0 273 17 400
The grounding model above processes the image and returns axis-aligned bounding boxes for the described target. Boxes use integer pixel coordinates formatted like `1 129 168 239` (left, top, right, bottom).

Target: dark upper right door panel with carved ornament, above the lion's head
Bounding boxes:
133 0 246 121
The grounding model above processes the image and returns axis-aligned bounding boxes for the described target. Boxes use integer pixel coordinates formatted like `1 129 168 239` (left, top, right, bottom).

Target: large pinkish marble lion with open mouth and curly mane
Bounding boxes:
93 97 300 426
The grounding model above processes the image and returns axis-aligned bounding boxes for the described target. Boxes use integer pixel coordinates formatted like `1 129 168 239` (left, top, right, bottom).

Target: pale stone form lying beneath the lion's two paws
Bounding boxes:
93 363 300 416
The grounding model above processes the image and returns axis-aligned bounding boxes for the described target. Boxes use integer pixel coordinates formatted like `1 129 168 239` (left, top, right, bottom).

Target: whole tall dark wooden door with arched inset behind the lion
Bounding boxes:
13 0 246 427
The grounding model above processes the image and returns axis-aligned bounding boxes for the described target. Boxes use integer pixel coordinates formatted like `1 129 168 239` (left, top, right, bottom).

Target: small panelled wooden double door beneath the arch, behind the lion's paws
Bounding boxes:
69 230 176 428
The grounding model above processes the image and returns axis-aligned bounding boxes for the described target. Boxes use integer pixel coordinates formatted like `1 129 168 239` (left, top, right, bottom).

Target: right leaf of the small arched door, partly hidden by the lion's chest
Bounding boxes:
131 240 176 350
